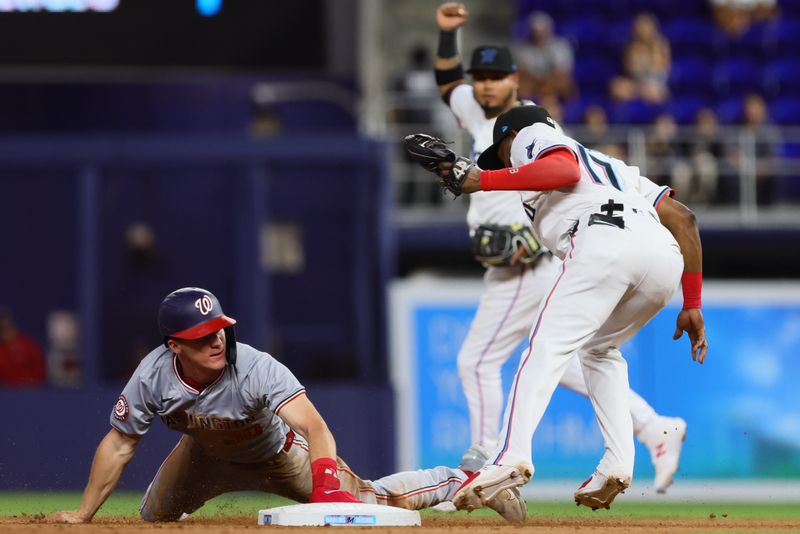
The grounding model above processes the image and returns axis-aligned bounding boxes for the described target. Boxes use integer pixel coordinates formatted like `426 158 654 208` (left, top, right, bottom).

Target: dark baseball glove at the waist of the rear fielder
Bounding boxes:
472 224 547 267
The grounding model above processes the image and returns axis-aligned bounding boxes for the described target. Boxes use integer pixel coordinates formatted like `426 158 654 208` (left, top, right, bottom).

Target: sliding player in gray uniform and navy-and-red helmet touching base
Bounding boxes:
47 288 512 523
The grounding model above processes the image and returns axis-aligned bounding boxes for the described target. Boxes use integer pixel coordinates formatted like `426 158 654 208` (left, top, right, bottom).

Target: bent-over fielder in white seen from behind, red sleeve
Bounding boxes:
416 106 708 520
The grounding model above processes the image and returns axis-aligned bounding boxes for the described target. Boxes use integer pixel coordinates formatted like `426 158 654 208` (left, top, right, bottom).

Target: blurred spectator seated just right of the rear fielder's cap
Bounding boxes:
514 11 575 101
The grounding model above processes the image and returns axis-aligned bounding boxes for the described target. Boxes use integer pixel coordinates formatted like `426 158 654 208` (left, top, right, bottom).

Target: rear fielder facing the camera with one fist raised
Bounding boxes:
435 2 686 493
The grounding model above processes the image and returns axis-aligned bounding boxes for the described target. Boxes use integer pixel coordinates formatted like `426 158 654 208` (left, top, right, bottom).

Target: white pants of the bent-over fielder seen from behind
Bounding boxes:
490 212 683 477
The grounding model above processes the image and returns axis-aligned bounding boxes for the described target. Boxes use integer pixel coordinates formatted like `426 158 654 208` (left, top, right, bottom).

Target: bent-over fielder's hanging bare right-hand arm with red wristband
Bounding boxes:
656 196 708 363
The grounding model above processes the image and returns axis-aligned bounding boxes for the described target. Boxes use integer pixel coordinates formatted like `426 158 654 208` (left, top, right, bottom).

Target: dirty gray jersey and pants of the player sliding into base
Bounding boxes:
110 343 466 521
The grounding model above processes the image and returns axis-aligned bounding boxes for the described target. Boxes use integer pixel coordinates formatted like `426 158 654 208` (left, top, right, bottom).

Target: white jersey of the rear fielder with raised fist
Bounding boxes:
450 84 531 230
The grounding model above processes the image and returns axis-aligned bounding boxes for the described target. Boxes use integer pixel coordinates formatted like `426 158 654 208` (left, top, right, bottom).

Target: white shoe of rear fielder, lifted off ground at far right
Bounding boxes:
640 416 686 493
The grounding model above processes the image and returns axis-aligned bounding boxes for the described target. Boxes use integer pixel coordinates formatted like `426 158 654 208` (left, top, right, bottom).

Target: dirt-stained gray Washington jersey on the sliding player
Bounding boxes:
110 343 305 463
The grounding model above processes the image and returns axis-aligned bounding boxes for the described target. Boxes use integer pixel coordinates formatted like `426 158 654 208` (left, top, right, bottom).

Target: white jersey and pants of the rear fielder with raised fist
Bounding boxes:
450 84 668 460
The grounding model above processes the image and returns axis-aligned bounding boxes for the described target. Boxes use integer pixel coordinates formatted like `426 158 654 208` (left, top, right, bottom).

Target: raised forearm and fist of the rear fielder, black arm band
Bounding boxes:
434 2 469 99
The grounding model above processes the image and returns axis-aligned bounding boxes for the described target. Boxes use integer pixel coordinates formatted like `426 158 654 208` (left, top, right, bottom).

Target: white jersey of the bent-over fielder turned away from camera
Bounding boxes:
511 123 670 259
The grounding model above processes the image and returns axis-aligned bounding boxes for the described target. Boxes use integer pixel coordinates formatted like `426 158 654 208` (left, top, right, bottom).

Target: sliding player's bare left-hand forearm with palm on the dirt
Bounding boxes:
46 428 141 523
